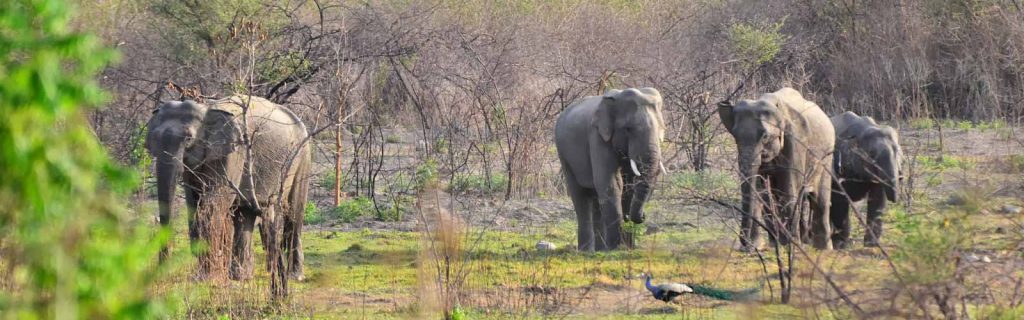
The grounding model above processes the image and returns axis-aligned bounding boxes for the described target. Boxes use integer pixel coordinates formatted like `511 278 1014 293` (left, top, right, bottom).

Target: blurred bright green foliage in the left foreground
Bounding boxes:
0 0 168 319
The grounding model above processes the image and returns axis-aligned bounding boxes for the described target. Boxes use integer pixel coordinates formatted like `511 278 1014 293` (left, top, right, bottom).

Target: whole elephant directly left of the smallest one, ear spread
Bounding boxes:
718 87 836 251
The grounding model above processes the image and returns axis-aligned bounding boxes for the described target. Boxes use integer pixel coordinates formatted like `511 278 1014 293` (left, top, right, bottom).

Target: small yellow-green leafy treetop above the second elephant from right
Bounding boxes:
729 18 785 68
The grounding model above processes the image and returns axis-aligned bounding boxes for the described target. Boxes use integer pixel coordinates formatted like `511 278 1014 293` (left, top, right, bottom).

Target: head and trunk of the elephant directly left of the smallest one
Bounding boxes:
718 95 788 183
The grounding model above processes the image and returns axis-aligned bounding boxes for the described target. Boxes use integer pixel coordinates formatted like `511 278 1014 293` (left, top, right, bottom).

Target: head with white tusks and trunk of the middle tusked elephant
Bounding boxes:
593 88 665 224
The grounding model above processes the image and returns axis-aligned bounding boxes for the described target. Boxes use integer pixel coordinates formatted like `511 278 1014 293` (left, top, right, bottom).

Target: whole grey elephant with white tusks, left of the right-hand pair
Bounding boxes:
555 87 666 251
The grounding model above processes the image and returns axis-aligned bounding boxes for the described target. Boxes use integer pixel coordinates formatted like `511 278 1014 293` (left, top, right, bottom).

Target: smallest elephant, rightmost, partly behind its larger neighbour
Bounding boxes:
830 112 903 248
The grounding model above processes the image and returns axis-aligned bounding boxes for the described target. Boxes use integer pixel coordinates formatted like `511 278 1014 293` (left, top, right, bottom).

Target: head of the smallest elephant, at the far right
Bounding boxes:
839 124 903 201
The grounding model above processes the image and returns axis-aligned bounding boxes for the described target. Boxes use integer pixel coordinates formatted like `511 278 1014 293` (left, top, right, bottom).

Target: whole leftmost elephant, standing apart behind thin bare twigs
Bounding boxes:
145 95 310 279
